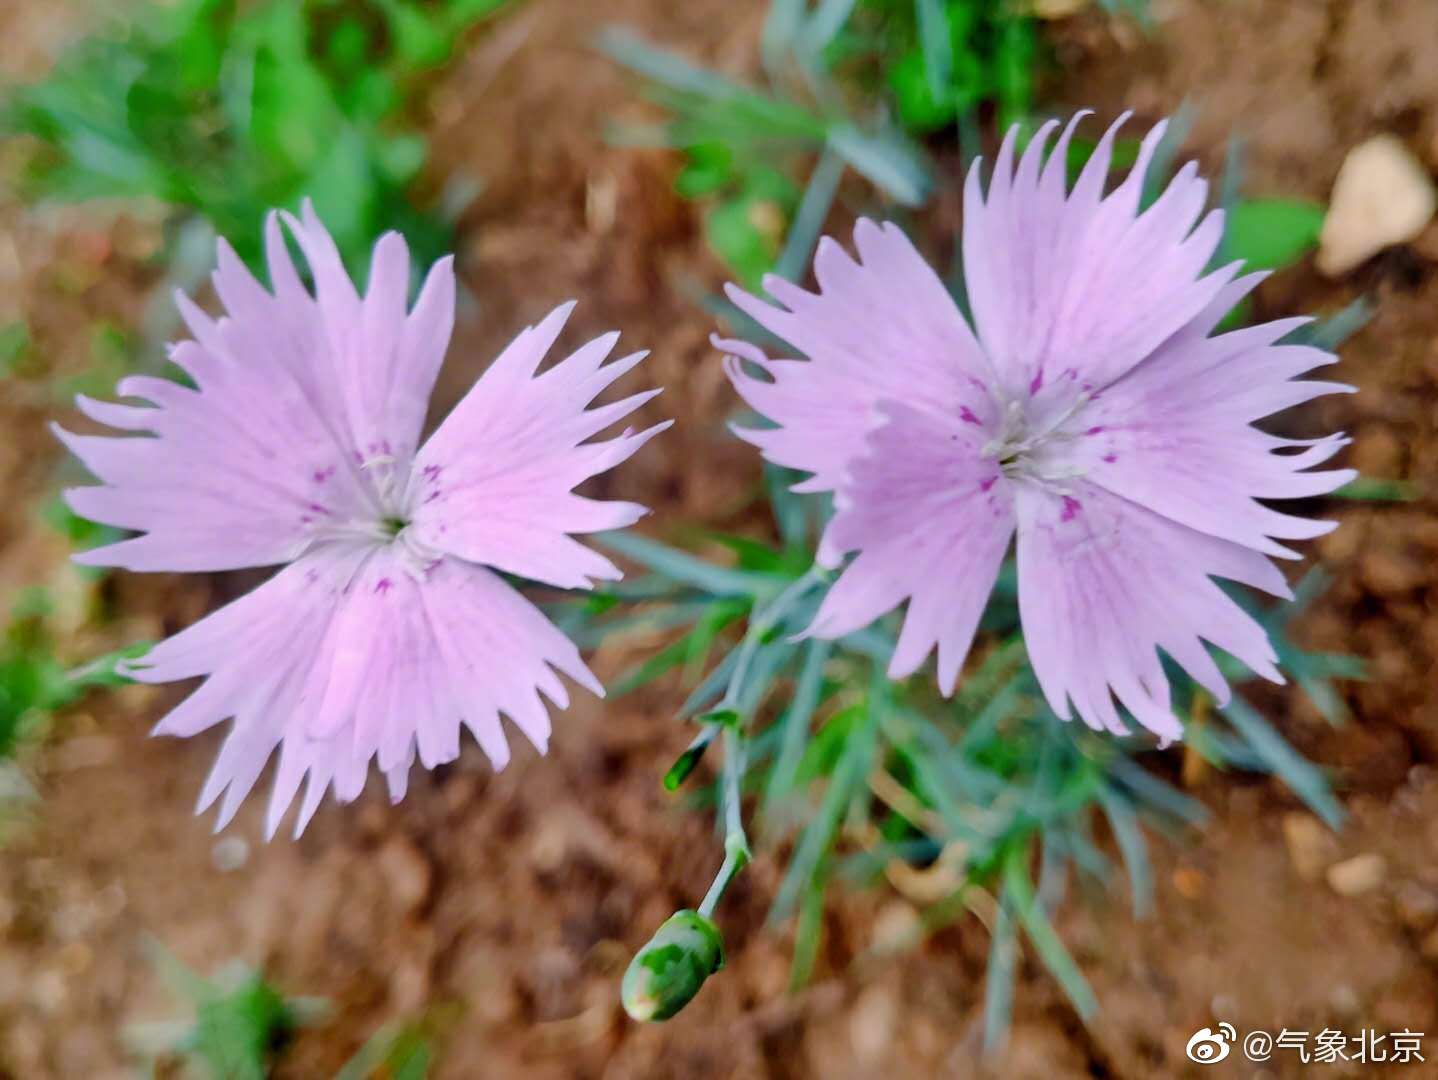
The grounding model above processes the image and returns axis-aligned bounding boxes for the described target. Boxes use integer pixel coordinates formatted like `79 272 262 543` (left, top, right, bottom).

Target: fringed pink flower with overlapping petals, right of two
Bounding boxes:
716 116 1353 741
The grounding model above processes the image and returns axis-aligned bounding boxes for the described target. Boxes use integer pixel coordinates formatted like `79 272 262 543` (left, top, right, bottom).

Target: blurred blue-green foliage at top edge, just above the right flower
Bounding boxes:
600 0 1146 288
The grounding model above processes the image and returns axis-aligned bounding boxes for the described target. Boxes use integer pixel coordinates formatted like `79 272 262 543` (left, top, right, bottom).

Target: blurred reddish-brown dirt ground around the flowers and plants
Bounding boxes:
0 0 1438 1080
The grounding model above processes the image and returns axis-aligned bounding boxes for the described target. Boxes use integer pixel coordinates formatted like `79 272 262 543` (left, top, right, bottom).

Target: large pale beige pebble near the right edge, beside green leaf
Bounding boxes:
1317 134 1438 278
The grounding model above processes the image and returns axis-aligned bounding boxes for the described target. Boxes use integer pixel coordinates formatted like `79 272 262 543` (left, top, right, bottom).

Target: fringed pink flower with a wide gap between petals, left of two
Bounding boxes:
58 204 669 836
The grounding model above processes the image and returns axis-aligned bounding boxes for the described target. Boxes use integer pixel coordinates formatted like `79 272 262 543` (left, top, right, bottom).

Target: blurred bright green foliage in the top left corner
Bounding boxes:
0 0 505 274
